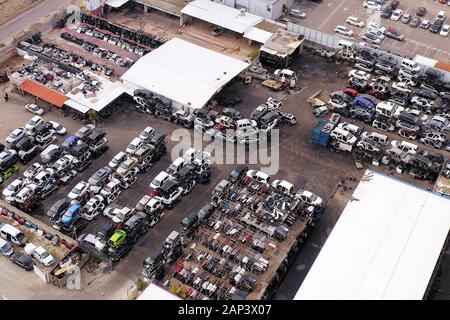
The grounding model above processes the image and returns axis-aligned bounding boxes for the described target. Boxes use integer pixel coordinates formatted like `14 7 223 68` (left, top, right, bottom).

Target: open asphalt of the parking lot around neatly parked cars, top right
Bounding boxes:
288 0 450 63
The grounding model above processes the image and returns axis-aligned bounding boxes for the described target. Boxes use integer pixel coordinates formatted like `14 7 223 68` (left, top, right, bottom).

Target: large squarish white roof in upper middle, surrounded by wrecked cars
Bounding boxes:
121 38 248 109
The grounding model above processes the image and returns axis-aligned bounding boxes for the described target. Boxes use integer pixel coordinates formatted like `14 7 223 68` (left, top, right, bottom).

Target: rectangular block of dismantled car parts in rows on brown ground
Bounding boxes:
142 165 325 299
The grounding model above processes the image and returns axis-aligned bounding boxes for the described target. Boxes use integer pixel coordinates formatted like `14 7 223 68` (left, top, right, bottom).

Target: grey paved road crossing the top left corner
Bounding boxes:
0 0 72 42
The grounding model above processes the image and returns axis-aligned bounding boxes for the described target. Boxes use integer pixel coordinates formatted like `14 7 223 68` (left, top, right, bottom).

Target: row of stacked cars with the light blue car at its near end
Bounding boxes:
47 127 166 233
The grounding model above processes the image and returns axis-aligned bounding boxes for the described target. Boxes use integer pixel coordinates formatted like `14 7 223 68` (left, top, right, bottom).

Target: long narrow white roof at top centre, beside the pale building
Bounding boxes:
181 0 264 33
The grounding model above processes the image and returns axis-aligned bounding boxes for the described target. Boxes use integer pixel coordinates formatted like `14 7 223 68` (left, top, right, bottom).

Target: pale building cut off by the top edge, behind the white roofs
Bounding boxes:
214 0 294 20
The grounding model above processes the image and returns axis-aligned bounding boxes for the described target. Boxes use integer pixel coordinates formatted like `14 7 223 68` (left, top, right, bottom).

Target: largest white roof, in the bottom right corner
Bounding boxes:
295 170 450 300
